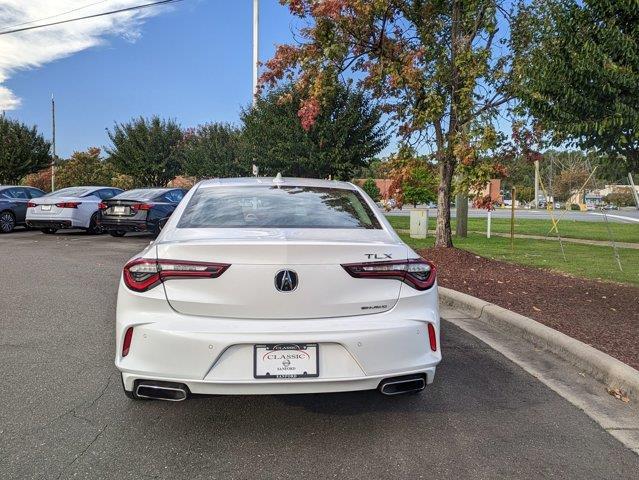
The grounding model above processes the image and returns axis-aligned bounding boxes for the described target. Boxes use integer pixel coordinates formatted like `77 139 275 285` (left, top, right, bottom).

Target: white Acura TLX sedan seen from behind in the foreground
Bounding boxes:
115 175 441 401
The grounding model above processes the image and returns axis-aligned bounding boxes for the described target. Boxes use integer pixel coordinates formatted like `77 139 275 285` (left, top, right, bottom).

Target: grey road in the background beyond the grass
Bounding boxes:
386 208 639 222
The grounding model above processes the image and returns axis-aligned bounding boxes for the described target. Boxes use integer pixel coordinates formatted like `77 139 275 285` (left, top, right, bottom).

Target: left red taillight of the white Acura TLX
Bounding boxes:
122 258 230 292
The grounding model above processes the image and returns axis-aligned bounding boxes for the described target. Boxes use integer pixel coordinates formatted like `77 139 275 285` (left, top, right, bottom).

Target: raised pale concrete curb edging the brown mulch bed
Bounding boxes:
439 287 639 400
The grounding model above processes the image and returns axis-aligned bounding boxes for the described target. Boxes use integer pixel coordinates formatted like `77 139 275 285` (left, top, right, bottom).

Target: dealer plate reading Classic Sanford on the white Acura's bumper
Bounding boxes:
253 343 319 378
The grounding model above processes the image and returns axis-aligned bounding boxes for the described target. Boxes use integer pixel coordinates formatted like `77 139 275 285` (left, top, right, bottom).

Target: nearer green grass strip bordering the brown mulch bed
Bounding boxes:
400 234 639 285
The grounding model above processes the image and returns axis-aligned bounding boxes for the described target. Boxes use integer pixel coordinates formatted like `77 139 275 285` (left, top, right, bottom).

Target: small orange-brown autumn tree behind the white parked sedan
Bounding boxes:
55 147 115 188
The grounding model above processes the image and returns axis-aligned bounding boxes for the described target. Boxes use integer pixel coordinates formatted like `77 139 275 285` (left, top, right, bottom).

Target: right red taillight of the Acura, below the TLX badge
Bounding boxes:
342 258 437 290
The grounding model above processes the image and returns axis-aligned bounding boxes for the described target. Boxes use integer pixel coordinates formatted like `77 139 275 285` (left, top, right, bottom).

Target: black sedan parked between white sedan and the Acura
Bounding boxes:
100 188 186 237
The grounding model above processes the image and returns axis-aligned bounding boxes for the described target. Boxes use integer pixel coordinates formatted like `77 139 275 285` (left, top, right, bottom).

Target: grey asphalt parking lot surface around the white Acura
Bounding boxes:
0 231 639 479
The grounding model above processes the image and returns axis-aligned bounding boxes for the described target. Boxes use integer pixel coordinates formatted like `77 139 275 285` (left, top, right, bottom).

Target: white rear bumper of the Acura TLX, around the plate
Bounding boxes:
115 292 441 394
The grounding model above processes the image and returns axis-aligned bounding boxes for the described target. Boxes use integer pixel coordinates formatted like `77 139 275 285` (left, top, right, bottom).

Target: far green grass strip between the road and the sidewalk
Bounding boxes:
386 214 639 243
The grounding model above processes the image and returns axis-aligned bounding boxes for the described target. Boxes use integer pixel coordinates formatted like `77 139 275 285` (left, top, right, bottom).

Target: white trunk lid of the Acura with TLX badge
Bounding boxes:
157 228 408 319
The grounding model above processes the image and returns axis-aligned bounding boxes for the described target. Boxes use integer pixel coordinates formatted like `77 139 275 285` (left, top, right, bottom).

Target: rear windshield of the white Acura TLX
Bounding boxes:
178 185 382 229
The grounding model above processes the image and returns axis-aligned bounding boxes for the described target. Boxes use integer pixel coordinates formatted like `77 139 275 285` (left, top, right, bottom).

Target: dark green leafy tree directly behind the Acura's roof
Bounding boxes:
240 84 388 180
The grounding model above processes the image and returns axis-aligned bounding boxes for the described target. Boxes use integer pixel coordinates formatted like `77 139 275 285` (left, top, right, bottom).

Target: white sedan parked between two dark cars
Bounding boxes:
27 187 122 233
